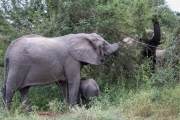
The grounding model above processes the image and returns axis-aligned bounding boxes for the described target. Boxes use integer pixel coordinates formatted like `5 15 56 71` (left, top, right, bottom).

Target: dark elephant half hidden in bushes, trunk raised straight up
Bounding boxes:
123 14 165 70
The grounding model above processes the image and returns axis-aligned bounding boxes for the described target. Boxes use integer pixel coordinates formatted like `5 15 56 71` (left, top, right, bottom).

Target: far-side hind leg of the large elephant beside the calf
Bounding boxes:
19 86 31 112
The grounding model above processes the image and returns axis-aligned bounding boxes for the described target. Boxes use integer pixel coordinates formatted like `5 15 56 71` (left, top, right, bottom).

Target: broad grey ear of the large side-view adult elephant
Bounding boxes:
68 34 101 65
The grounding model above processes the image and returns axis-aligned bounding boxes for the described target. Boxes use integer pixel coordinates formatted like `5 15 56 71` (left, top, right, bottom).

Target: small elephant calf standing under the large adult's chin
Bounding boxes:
78 78 100 104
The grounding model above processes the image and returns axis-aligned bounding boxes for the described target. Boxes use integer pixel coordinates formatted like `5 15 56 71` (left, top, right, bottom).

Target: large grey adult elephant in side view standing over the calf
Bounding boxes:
2 33 119 108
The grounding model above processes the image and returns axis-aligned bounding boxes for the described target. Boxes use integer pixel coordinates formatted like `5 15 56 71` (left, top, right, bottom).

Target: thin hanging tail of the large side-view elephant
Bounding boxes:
1 58 9 107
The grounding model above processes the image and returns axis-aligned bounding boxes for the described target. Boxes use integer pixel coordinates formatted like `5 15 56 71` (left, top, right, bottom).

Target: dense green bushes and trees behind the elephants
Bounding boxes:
0 0 180 118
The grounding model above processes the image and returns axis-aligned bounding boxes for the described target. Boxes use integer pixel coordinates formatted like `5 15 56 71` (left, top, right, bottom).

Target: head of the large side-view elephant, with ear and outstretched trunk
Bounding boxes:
68 33 119 65
